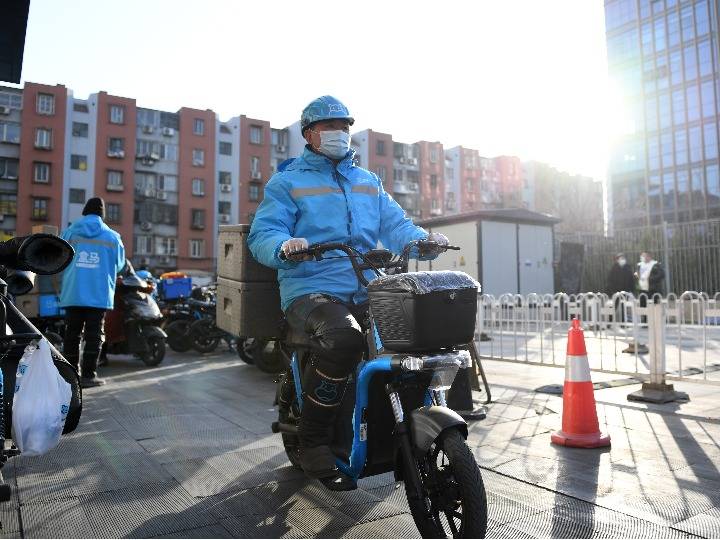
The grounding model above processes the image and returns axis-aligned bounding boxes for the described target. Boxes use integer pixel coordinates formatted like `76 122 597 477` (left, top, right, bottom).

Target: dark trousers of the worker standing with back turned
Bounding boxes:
63 307 105 377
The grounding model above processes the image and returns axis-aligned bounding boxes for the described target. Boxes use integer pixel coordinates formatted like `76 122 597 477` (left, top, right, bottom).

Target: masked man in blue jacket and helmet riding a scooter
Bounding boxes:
248 96 448 489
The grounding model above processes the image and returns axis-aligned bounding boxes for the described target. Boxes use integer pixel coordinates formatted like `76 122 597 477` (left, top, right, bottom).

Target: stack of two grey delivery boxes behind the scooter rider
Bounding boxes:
217 224 283 338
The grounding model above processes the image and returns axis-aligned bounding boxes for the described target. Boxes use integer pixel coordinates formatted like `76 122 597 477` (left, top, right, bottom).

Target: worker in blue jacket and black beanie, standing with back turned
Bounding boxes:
60 197 125 387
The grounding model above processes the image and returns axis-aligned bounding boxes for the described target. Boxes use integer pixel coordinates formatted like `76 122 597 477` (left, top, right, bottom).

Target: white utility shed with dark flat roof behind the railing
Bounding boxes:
417 208 560 296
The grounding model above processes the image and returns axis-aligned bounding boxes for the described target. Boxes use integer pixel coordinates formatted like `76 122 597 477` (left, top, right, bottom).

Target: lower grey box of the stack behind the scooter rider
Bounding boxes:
217 277 283 338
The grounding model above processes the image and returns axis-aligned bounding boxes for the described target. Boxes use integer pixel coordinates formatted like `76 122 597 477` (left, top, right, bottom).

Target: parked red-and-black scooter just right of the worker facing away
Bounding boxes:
102 261 167 366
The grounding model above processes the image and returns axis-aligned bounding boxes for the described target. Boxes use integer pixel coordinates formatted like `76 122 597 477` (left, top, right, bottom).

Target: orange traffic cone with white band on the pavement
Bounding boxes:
550 319 610 448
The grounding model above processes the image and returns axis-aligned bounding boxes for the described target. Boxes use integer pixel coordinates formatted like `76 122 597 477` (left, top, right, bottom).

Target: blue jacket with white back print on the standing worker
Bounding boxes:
60 214 125 309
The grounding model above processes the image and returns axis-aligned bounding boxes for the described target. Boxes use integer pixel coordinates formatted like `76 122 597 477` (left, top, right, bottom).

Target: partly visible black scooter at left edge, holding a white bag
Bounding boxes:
0 234 82 501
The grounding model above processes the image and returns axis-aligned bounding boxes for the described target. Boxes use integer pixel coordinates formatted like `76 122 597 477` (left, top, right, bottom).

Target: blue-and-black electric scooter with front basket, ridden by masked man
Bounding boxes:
272 241 487 538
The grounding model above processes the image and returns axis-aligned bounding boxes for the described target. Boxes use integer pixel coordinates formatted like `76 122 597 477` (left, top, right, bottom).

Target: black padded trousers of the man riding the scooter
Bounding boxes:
285 294 367 448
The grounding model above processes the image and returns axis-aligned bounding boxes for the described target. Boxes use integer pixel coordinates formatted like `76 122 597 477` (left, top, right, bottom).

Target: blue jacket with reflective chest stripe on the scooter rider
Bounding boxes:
248 148 427 310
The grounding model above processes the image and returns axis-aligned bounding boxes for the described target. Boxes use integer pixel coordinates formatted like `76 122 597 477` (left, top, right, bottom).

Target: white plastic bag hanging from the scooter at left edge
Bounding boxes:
12 338 72 456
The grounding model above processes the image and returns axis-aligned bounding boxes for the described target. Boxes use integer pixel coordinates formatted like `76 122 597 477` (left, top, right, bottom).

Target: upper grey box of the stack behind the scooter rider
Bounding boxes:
218 224 277 282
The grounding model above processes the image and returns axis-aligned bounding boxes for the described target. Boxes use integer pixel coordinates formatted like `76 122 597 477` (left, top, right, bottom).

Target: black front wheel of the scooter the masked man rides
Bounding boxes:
405 428 487 538
